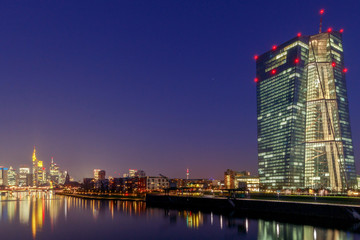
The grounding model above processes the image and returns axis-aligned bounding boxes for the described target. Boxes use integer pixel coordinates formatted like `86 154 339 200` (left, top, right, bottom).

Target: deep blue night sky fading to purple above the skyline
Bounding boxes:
0 0 360 179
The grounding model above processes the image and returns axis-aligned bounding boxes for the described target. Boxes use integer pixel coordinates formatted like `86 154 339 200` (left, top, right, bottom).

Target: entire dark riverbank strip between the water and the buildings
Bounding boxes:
56 192 360 223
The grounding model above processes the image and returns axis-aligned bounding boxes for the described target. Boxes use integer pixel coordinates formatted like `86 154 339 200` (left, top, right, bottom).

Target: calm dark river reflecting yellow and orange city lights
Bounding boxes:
0 193 360 240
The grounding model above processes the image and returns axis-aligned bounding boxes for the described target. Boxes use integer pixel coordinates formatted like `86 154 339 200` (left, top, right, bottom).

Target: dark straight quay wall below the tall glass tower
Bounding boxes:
146 194 360 222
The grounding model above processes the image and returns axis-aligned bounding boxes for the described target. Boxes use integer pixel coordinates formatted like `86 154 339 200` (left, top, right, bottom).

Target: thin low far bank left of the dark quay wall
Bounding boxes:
56 192 145 201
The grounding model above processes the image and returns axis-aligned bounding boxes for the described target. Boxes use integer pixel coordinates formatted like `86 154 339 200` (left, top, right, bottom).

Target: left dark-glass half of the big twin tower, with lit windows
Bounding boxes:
255 36 308 189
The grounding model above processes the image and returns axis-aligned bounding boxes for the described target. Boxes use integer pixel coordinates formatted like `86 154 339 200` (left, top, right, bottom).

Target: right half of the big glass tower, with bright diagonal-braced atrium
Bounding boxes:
305 29 356 191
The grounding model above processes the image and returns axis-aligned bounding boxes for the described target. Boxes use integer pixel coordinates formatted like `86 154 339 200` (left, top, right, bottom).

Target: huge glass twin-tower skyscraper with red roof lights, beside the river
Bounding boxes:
255 29 356 191
